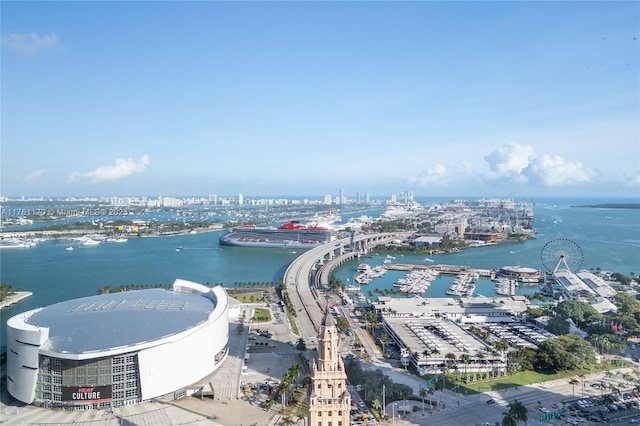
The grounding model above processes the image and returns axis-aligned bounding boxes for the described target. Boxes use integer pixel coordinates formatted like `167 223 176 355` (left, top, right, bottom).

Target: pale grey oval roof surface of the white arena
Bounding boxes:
25 289 216 354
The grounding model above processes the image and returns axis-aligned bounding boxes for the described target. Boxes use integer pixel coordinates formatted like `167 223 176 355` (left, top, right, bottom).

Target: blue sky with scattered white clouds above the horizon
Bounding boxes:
0 2 640 197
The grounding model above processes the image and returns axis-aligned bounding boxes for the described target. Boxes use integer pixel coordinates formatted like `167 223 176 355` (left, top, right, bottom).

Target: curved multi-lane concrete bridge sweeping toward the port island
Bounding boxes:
284 232 409 338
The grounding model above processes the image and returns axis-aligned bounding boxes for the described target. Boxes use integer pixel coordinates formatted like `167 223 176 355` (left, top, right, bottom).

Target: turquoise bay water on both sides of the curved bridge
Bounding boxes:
0 199 640 344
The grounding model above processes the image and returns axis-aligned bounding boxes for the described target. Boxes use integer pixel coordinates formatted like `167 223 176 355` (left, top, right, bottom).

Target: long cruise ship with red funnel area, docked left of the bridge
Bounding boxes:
219 220 335 249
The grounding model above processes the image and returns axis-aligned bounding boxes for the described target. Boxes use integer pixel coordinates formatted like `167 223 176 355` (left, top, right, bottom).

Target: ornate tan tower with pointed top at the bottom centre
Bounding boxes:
308 306 351 426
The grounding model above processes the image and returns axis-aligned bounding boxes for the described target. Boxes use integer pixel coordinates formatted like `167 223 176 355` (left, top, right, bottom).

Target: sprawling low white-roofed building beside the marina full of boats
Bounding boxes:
374 296 533 375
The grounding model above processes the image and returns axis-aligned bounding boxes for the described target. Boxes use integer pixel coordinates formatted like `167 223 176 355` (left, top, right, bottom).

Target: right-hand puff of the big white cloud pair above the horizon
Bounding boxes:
523 155 596 186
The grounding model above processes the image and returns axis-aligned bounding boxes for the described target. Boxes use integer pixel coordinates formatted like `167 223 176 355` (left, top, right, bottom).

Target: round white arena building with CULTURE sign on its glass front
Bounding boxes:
7 280 229 410
